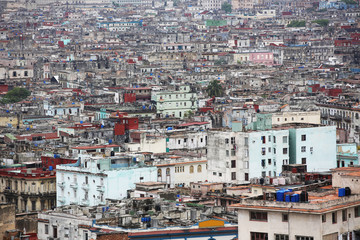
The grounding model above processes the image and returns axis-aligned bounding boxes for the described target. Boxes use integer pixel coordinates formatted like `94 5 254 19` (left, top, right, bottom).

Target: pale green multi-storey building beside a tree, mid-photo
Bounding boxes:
153 86 198 118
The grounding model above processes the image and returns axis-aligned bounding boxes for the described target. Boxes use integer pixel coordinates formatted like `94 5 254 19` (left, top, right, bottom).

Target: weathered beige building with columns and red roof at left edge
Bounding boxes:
0 169 56 213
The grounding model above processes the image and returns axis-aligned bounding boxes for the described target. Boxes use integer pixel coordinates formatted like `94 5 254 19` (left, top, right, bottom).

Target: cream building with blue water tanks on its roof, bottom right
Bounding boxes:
232 174 360 240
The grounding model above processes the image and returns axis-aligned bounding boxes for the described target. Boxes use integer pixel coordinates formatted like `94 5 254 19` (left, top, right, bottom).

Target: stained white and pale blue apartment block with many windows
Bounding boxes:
207 130 289 184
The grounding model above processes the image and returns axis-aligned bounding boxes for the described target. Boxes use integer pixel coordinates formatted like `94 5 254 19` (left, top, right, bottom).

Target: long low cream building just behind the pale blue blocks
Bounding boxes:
272 111 320 126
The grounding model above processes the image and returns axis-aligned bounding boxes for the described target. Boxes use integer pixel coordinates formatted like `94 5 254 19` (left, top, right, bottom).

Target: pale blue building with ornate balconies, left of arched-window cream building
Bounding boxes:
56 156 157 206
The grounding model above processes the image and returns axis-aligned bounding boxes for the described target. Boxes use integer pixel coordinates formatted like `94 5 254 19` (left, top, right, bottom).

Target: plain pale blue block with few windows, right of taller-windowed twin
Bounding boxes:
289 126 336 172
